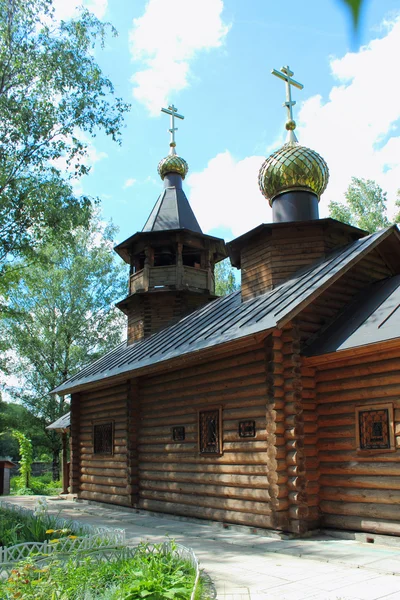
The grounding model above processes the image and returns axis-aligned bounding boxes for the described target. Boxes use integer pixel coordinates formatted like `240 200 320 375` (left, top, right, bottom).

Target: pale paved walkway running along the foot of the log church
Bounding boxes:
4 496 400 600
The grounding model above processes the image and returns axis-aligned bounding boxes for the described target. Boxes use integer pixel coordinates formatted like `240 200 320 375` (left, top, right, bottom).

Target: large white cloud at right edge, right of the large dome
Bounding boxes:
298 19 400 216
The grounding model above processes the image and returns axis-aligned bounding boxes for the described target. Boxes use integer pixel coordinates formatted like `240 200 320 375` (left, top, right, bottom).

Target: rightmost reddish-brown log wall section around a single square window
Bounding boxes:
316 348 400 535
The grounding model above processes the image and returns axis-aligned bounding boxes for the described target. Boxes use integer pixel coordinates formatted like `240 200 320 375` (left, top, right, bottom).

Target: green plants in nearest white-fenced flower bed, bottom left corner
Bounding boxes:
0 542 195 600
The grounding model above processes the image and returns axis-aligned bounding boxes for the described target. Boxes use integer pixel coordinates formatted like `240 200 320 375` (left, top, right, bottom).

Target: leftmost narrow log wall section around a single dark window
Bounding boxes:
78 383 130 506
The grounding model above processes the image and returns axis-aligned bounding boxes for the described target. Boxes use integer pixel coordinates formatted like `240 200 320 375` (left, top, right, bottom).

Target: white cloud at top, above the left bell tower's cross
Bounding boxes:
130 0 229 115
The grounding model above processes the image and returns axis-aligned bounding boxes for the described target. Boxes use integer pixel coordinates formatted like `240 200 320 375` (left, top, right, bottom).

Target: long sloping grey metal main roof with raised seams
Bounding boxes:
53 227 396 394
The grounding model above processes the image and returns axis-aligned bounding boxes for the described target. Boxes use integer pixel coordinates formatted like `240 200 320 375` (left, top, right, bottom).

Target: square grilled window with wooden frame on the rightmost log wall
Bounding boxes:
356 404 395 452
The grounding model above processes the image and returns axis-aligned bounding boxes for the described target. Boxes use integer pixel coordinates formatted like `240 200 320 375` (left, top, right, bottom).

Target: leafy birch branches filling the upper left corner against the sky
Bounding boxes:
0 0 128 274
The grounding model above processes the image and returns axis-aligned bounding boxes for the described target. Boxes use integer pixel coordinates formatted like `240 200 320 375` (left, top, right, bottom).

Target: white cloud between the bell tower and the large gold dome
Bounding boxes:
187 150 271 237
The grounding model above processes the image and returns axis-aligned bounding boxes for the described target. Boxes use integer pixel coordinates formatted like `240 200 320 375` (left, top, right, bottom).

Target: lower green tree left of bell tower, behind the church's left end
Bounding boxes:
3 214 126 479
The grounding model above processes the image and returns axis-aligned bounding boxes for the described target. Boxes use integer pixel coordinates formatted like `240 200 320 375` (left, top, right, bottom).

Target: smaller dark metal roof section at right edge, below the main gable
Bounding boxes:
305 275 400 356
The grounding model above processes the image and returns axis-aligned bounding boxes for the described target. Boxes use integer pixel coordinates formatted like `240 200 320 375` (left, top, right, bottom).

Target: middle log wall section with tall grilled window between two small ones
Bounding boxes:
139 346 288 527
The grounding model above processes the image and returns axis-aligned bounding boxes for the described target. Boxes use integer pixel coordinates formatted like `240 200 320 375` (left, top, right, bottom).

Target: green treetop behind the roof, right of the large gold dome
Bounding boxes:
329 177 400 233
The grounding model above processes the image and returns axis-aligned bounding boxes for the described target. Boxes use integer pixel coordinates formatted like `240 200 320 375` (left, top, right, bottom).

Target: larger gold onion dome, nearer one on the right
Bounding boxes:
258 140 329 206
